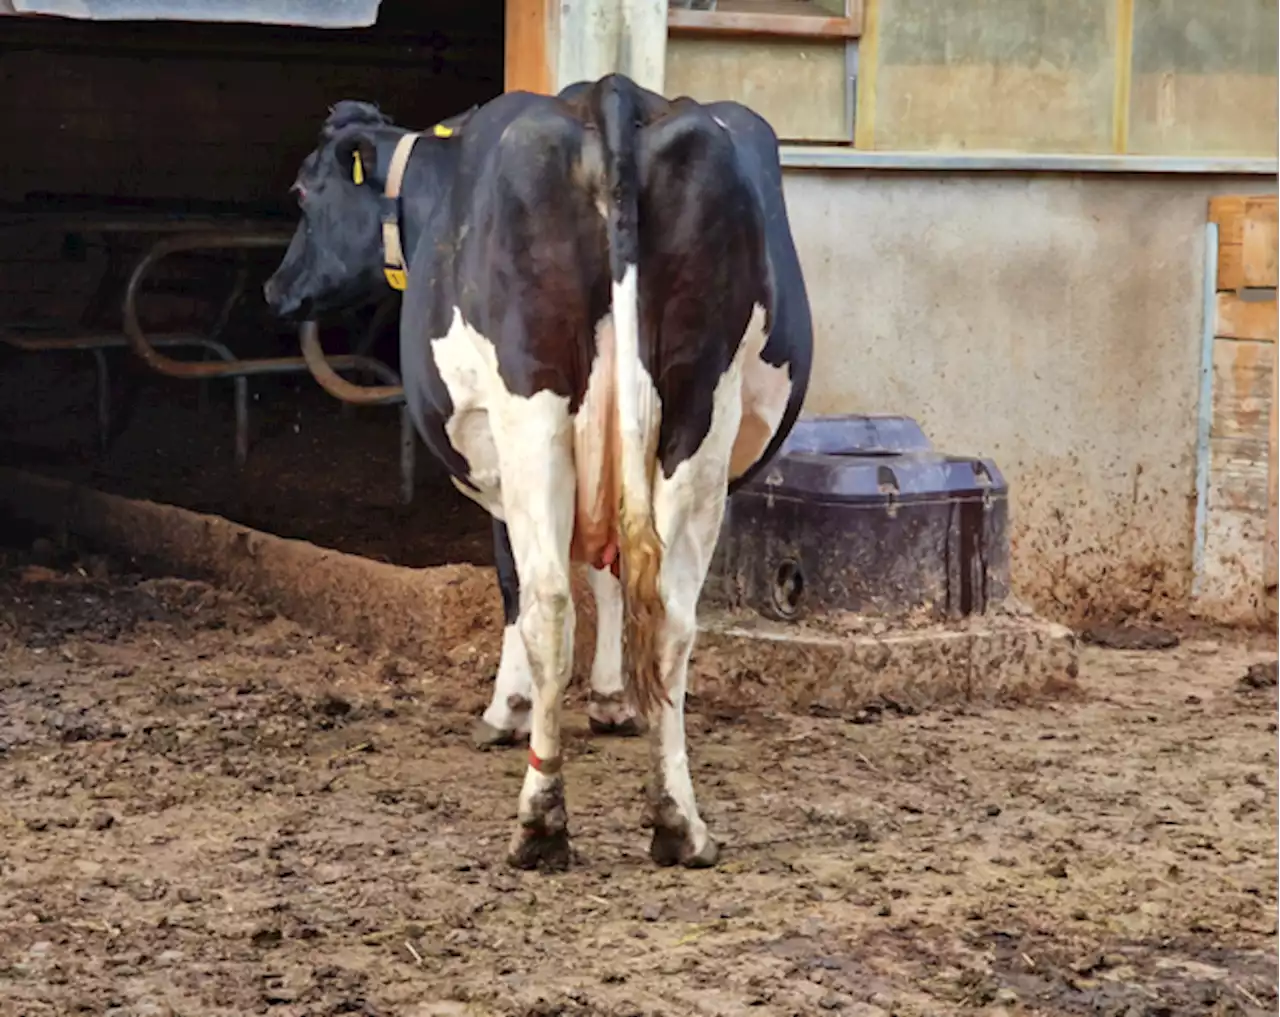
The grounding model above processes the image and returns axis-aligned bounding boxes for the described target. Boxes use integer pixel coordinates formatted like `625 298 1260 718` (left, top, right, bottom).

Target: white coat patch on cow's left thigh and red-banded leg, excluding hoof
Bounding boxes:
431 308 576 820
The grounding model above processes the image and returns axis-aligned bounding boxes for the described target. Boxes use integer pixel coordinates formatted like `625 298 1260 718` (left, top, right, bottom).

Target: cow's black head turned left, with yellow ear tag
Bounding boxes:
264 100 403 317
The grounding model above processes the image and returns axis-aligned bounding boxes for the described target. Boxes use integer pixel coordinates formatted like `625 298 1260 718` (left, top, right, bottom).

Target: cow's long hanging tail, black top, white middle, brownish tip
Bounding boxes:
596 77 671 716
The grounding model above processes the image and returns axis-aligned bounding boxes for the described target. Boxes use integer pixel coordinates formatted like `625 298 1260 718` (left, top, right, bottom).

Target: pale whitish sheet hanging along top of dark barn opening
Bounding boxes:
0 0 380 28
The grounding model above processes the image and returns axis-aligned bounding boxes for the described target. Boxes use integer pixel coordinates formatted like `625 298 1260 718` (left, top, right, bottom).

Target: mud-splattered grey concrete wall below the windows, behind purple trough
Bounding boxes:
787 170 1268 623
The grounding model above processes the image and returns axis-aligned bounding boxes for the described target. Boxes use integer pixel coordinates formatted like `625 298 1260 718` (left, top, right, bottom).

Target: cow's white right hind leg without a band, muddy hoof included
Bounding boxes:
649 406 740 869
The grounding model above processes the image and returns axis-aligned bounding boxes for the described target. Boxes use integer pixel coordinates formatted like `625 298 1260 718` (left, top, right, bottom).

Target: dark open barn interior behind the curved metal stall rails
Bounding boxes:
0 0 503 565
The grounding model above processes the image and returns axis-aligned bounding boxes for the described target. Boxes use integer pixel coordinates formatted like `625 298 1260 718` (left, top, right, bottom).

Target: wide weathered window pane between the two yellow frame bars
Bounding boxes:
872 0 1115 152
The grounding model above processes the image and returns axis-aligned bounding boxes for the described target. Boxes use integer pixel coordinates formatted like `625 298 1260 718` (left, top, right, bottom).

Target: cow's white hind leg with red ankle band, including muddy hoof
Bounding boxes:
494 391 575 870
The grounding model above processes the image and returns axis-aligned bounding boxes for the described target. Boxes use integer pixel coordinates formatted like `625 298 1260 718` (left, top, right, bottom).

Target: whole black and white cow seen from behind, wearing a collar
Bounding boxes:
266 75 813 869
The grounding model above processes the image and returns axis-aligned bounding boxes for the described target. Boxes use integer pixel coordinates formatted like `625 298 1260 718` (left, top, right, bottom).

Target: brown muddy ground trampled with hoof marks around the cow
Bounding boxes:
0 551 1277 1017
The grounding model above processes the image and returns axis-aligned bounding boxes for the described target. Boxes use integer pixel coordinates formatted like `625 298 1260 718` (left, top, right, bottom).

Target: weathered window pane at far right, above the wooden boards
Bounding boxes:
1128 0 1276 156
